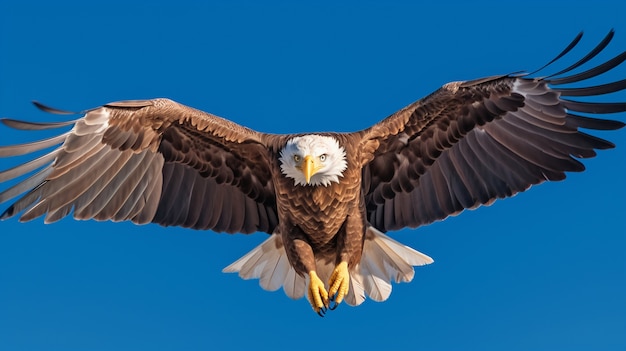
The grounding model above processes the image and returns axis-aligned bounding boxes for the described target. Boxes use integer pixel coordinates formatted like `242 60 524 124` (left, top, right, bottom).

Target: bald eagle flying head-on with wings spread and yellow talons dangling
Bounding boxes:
0 31 626 315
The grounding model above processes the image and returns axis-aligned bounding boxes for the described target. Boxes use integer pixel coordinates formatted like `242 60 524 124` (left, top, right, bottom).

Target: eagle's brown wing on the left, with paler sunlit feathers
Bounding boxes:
0 99 277 233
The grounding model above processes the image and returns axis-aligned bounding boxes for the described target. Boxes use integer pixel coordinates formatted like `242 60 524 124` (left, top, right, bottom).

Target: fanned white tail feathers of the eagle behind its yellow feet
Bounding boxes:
223 227 433 306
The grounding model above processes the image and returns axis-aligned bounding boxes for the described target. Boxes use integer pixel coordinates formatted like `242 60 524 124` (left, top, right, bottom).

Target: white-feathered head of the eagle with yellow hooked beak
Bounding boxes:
280 134 348 186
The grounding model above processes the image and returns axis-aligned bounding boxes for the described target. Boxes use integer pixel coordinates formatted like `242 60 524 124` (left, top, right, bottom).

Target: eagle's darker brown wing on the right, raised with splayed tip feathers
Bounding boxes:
362 31 626 231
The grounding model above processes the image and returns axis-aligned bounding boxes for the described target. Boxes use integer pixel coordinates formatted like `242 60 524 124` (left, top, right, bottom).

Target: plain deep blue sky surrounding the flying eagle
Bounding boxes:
0 0 626 350
